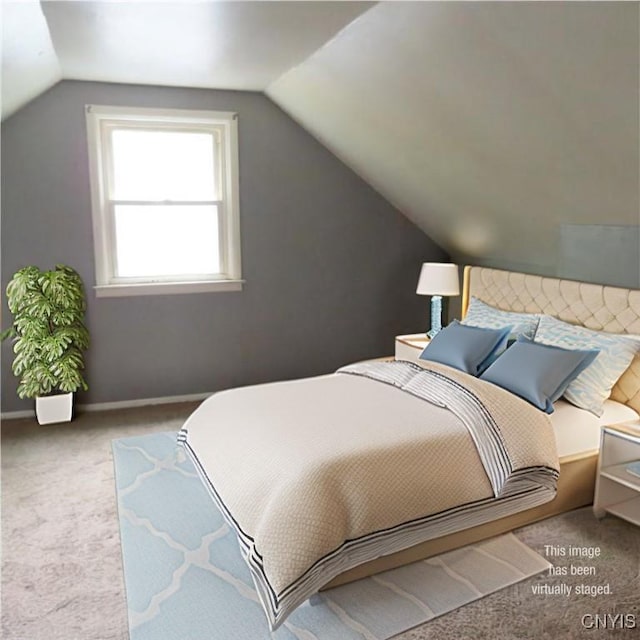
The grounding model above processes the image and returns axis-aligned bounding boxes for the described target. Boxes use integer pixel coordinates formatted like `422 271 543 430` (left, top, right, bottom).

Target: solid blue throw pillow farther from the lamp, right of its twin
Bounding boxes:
480 338 600 413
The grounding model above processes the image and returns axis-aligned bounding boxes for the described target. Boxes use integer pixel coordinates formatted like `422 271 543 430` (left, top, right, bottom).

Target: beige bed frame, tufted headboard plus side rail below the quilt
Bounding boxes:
324 266 640 589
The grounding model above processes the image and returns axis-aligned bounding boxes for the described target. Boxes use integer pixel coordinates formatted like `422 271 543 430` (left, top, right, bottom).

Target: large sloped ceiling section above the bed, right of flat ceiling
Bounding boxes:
267 2 638 264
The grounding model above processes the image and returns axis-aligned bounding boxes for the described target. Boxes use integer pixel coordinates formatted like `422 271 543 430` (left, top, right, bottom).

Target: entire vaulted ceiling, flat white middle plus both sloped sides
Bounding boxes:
2 0 639 266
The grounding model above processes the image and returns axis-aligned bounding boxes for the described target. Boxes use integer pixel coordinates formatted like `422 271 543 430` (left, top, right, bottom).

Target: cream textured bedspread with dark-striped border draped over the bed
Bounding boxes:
180 362 559 627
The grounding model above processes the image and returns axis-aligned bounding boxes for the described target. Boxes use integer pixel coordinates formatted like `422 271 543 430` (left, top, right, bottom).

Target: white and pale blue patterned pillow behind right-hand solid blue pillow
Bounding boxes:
535 316 640 416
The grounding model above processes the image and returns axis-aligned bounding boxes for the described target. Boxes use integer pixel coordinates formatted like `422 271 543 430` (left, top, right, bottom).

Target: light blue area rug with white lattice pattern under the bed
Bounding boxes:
113 433 549 640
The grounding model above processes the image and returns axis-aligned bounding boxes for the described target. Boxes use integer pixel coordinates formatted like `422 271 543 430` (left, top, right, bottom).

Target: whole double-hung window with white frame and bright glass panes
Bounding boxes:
86 105 242 296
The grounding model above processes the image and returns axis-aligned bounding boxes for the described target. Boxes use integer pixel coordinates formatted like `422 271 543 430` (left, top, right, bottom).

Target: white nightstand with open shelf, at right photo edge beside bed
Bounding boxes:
593 422 640 525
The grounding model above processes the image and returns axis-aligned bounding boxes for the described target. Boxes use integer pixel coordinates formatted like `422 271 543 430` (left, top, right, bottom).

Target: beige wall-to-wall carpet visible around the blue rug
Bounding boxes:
2 404 640 640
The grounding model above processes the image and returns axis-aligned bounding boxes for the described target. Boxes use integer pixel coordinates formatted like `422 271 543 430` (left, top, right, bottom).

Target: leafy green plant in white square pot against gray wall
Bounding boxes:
0 264 89 424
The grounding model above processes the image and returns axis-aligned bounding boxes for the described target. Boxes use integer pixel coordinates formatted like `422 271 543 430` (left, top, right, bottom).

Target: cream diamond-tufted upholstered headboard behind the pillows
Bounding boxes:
462 266 640 413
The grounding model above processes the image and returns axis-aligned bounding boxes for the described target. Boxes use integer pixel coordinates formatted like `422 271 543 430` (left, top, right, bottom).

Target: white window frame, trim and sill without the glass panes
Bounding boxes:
85 105 244 297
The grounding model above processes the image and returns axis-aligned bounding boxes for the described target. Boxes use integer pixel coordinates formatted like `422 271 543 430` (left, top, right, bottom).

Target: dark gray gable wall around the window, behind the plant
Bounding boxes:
2 81 447 412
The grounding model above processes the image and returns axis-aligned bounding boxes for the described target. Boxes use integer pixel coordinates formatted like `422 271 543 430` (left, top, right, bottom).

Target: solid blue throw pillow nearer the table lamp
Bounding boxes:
420 320 511 376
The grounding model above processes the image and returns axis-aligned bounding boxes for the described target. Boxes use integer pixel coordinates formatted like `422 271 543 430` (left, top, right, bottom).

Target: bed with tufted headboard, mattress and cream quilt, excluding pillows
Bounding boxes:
179 267 640 628
